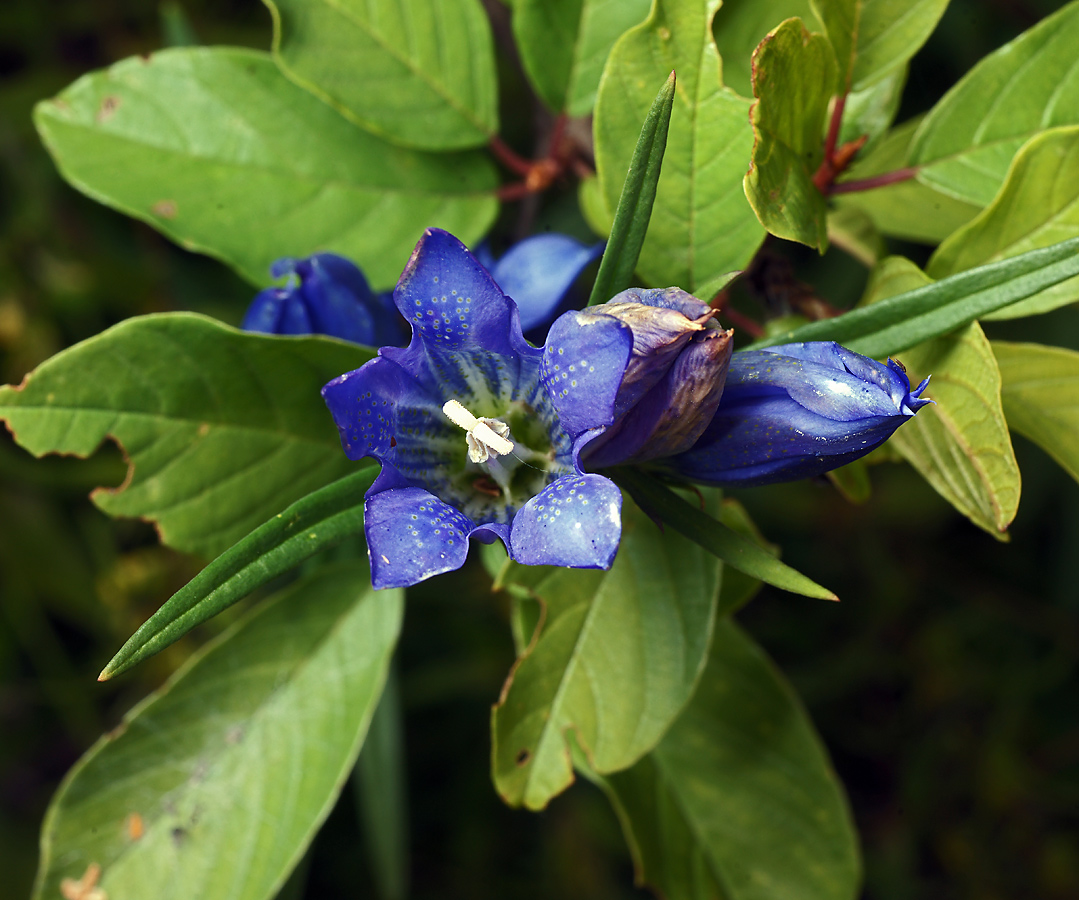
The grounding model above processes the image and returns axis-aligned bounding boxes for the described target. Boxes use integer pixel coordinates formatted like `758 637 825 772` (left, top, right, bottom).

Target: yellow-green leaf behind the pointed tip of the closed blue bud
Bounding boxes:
866 257 1020 537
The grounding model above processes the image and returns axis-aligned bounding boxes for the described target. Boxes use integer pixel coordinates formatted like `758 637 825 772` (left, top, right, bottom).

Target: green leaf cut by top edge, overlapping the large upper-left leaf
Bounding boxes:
265 0 498 150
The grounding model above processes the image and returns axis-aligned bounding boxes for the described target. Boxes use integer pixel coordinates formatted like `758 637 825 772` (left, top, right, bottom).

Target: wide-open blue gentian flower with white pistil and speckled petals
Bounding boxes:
323 229 622 588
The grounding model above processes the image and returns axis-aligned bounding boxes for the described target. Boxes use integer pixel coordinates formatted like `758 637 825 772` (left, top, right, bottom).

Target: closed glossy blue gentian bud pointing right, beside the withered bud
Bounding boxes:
661 341 931 487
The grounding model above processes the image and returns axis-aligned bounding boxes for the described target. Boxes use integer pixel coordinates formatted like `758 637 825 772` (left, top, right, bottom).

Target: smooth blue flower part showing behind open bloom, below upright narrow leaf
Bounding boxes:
476 233 604 340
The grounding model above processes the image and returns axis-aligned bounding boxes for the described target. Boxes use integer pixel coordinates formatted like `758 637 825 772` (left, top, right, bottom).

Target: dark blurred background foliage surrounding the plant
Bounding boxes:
0 0 1079 900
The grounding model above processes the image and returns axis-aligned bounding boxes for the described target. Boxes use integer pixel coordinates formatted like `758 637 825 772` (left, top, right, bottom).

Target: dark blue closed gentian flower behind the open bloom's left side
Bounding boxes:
240 254 405 346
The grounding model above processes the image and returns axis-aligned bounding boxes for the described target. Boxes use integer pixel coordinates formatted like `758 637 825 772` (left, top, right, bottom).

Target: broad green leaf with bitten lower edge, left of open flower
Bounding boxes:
0 313 372 558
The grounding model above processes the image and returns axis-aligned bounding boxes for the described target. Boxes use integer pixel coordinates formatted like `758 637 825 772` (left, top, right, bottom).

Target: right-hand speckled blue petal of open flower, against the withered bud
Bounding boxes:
543 311 633 437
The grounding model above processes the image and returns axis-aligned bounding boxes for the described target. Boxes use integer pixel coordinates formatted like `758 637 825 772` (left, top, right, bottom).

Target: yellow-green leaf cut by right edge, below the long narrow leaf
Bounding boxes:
993 341 1079 481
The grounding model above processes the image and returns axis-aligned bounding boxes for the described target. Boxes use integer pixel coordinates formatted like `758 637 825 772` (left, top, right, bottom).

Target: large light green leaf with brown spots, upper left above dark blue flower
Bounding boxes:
35 49 498 290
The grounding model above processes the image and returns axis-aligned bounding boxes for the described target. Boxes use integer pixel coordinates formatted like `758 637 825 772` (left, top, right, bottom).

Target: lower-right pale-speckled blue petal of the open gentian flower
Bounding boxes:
509 475 622 569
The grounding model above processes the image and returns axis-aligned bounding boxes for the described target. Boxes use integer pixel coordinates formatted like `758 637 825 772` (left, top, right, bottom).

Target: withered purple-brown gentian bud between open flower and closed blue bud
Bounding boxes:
545 287 732 468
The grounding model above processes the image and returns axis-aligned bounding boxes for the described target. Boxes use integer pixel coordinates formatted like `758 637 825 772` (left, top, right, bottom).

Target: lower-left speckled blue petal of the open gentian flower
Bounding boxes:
364 488 474 588
